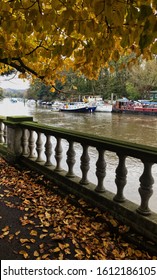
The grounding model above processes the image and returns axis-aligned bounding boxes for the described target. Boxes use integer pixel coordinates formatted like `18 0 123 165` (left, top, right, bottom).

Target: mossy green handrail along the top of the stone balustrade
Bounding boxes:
19 122 157 163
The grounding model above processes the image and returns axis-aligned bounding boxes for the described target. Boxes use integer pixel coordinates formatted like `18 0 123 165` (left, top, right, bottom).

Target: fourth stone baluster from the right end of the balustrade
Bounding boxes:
80 145 90 185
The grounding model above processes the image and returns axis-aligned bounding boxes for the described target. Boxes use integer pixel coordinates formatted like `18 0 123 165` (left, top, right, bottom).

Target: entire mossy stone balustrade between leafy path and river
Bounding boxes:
0 117 157 242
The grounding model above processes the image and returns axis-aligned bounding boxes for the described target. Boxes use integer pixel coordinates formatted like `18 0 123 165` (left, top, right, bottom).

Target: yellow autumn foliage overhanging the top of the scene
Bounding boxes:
0 0 157 84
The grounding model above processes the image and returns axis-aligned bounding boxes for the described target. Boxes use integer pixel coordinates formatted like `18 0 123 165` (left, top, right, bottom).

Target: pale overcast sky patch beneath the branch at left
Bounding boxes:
0 75 29 89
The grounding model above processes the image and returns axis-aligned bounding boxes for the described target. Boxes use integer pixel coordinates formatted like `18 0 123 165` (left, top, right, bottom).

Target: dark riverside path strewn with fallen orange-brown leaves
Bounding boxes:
0 157 157 260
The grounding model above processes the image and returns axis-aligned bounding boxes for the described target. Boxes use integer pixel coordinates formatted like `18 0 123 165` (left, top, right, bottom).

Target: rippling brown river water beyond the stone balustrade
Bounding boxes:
0 99 157 212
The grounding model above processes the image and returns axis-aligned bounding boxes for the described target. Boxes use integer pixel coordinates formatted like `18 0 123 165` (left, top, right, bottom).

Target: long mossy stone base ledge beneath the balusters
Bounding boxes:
15 157 157 245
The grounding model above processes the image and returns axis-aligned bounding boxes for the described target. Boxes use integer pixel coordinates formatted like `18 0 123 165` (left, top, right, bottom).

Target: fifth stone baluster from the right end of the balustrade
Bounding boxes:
66 141 76 177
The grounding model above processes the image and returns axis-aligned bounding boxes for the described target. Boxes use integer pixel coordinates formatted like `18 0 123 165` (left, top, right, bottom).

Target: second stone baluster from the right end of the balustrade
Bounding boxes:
113 153 127 202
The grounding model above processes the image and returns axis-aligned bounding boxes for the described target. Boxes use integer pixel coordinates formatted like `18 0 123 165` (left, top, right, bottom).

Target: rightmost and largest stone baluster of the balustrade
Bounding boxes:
137 161 154 216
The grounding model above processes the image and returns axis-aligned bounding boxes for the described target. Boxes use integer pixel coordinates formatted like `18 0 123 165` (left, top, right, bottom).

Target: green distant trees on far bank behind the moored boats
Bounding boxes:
26 57 157 101
